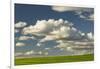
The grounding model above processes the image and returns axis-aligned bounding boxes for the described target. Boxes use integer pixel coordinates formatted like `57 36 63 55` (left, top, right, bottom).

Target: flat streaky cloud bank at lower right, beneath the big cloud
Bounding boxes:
54 40 94 55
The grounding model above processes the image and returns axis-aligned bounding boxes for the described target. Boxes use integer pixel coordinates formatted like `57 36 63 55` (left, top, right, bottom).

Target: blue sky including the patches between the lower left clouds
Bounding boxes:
15 4 94 54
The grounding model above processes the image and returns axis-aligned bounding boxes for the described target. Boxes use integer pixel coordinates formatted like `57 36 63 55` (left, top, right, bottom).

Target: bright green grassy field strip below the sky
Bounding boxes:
15 54 94 65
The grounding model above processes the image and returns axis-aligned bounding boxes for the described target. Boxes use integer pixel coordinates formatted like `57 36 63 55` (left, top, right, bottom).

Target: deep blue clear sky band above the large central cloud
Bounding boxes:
15 4 94 32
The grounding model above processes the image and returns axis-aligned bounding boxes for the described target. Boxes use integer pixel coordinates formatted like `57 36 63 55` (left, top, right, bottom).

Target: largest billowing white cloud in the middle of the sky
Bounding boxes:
23 19 81 40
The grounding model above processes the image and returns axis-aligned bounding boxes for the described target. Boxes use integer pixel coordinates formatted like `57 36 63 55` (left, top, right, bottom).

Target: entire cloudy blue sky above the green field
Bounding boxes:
15 4 94 57
